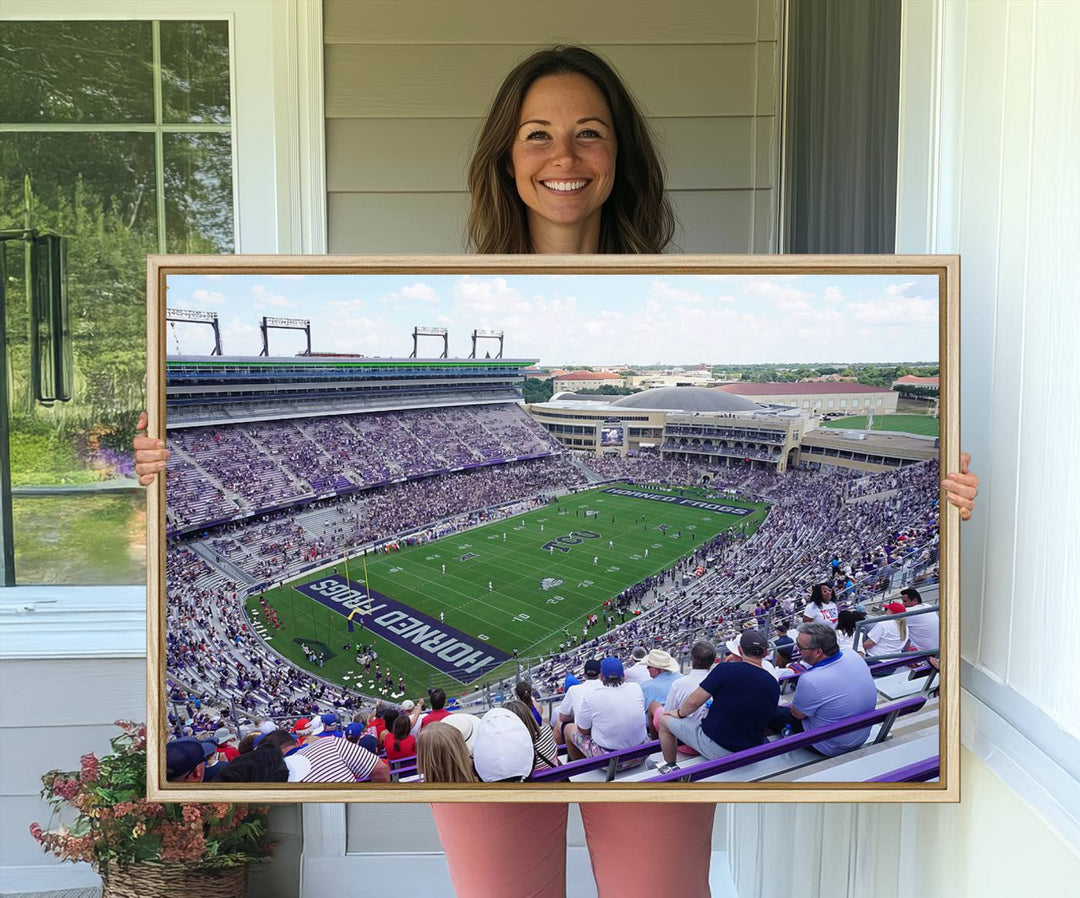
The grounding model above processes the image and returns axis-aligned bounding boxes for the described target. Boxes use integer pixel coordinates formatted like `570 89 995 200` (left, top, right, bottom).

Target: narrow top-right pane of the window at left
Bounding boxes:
161 22 229 123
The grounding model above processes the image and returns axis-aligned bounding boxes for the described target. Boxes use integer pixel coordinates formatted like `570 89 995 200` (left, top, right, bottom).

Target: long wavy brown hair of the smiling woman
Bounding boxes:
468 46 675 254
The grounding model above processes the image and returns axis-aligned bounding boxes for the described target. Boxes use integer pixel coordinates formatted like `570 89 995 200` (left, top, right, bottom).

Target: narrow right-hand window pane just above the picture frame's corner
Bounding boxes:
164 134 233 253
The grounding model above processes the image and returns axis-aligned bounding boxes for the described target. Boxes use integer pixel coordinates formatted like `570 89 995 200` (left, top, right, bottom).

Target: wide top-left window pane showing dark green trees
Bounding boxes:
0 22 153 123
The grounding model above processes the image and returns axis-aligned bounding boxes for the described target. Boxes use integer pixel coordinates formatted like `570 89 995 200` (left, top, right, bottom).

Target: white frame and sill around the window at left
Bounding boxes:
0 0 326 659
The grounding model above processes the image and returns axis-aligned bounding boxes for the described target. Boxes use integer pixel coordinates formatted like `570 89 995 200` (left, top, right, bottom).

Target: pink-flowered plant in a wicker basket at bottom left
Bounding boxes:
30 721 273 898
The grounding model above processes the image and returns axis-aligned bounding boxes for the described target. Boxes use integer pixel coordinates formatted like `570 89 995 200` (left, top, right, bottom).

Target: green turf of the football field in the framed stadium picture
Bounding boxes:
247 484 767 699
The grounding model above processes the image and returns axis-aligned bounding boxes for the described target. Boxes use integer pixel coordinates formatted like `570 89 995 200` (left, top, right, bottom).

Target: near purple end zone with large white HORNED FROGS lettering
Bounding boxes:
294 574 510 683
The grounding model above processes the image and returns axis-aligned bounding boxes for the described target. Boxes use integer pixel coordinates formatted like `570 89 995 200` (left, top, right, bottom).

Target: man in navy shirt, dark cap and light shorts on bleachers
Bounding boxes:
659 630 781 774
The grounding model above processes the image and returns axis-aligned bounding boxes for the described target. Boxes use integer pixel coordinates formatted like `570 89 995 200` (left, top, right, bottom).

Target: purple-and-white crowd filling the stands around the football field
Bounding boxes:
166 406 937 781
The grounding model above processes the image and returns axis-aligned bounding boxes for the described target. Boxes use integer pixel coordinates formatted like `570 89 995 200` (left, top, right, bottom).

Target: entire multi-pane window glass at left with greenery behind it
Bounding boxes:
0 22 234 585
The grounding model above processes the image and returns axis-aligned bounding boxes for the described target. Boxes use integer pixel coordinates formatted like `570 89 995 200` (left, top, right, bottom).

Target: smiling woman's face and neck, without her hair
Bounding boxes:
510 75 617 252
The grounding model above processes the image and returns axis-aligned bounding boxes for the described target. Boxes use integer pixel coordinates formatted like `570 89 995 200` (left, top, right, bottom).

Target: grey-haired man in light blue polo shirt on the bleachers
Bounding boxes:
772 624 877 755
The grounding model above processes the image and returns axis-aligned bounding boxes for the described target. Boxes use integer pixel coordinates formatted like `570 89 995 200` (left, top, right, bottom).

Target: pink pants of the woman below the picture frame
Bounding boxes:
431 803 716 898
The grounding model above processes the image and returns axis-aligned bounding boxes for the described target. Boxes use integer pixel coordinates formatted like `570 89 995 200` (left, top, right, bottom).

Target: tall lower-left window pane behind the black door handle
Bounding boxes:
0 133 158 584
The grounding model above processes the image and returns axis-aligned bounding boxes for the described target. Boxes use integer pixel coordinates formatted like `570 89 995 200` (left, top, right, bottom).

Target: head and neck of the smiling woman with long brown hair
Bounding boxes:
468 46 675 254
